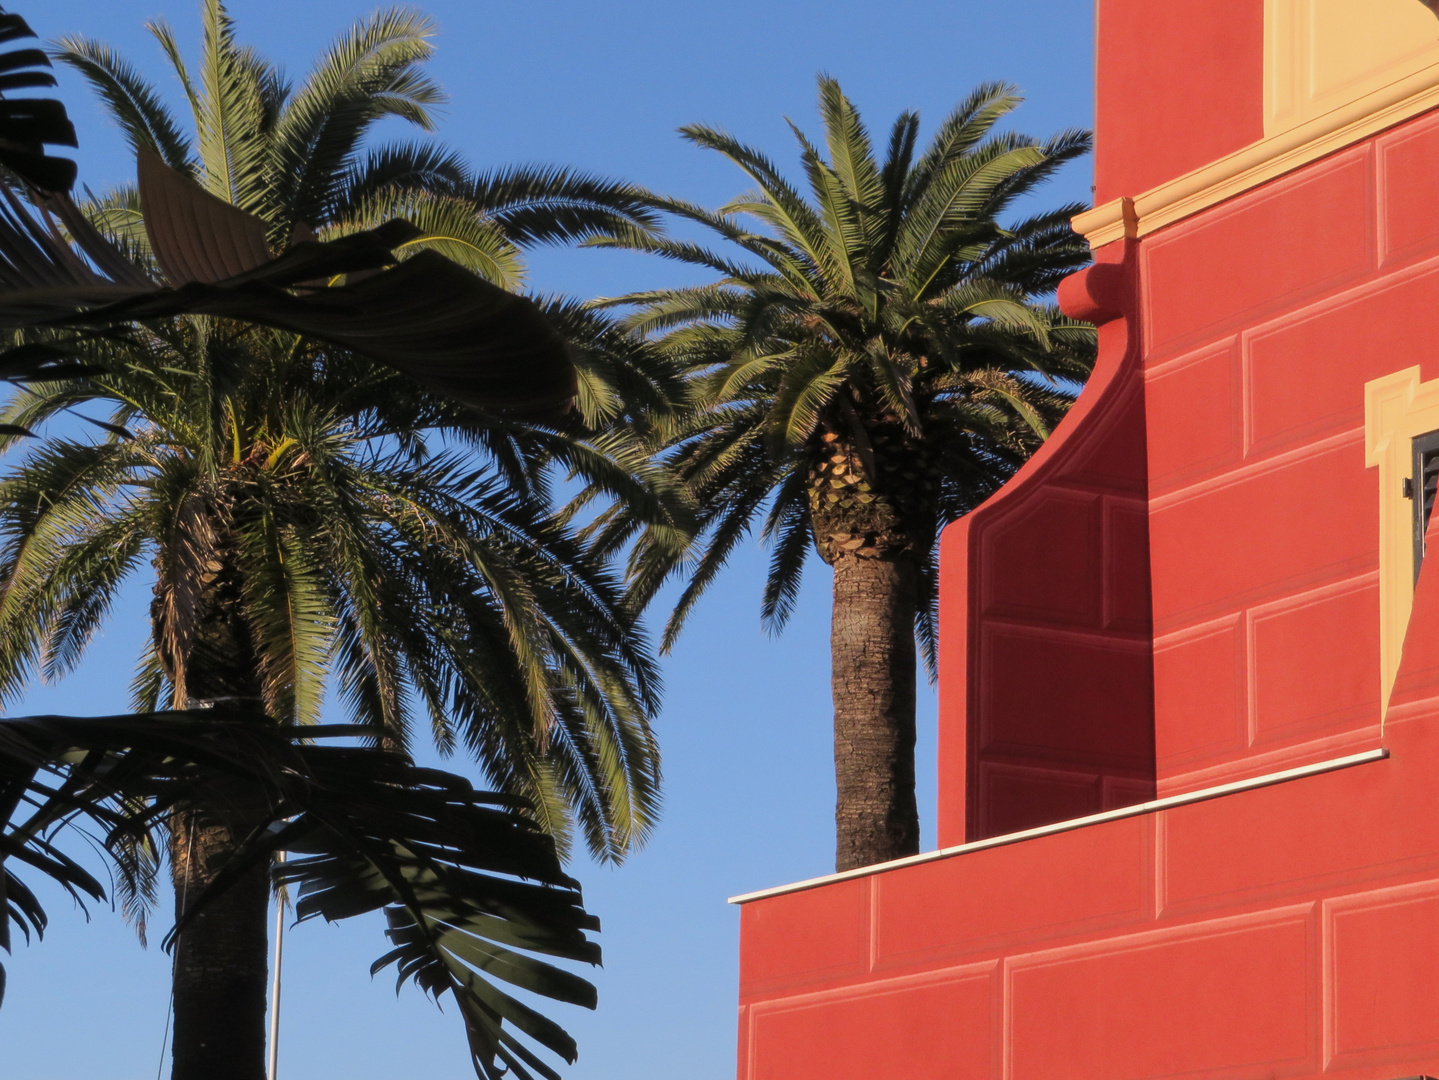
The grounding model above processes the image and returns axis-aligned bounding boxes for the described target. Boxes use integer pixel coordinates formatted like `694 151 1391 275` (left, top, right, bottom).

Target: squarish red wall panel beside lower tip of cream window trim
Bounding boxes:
1250 575 1380 745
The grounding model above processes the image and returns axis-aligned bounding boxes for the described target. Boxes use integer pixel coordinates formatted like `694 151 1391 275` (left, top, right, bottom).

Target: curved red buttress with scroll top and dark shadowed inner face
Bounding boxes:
938 234 1156 847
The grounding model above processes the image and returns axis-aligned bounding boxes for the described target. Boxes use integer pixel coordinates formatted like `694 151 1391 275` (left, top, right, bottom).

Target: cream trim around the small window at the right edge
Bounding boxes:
1364 368 1439 712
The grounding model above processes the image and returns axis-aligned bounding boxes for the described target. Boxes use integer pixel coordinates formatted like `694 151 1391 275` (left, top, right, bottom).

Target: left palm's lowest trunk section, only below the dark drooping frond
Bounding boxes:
170 810 271 1080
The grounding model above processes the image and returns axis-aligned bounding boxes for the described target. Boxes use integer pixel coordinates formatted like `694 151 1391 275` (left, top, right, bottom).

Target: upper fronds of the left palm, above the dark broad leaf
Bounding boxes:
55 0 650 288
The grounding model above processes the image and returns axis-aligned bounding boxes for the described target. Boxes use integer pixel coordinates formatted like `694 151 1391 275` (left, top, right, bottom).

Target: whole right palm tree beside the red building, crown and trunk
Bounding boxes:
593 78 1094 870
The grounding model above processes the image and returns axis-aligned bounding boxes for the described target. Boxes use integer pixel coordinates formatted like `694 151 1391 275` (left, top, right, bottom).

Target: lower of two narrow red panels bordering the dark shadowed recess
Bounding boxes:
1154 615 1249 777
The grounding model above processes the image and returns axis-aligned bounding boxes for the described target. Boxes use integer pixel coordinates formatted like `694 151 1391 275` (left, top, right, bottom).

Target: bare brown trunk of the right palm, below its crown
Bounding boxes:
830 555 920 871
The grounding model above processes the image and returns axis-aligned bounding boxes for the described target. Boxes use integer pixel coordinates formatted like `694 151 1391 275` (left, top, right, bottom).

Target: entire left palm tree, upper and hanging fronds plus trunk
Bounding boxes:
0 0 679 1080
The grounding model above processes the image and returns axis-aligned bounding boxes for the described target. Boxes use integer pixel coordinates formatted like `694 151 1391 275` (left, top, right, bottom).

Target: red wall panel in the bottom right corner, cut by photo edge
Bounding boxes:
1325 882 1439 1066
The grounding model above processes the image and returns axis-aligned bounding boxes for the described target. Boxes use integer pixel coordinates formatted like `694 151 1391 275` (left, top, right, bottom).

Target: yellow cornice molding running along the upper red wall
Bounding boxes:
1072 63 1439 249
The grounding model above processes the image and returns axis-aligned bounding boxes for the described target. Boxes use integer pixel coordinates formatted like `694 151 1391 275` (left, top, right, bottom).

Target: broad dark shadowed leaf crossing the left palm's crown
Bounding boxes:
0 153 576 413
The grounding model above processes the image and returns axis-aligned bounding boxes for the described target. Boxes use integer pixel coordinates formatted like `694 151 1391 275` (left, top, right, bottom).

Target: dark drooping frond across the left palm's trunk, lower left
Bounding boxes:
0 709 600 1080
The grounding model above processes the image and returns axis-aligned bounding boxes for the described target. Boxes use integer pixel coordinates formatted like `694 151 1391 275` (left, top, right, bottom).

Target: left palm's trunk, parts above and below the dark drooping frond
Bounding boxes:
151 529 271 1080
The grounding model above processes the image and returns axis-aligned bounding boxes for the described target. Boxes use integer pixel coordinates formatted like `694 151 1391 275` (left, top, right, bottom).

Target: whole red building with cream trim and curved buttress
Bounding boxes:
738 0 1439 1080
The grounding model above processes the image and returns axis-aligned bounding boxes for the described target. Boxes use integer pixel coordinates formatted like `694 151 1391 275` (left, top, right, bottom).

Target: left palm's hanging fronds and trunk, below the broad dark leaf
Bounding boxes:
0 304 658 1079
